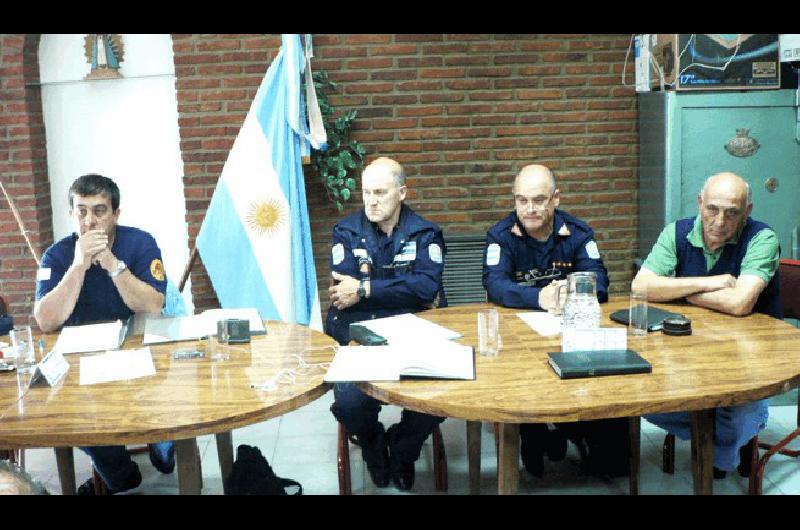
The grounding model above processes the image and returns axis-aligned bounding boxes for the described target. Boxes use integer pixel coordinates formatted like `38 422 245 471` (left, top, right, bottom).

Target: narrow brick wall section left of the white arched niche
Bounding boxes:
0 34 53 324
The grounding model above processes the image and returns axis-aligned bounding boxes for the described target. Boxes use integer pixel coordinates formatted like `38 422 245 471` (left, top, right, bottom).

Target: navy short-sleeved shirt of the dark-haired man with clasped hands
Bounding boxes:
36 225 167 326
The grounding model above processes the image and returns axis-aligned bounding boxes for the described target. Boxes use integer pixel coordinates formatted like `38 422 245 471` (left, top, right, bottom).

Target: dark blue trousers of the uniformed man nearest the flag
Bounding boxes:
331 383 445 463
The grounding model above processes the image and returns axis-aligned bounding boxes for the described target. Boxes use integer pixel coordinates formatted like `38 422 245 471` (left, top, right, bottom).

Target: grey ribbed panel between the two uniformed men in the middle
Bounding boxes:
442 234 486 306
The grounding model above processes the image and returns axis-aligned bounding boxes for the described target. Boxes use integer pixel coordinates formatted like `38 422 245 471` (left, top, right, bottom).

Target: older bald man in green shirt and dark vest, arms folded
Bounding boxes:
632 173 783 478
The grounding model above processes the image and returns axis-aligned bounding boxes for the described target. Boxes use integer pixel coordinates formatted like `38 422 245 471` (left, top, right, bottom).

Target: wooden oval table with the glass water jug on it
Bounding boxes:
361 298 800 493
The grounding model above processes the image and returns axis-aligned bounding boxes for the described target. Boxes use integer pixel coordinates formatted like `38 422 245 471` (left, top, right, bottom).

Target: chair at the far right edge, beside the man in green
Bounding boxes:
750 259 800 495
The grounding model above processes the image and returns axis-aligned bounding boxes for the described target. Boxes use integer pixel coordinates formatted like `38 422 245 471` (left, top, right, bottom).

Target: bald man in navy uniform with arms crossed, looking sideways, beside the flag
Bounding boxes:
325 158 445 490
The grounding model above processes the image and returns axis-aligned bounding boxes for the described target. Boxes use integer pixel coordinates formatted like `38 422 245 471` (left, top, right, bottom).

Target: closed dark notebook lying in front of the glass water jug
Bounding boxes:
547 350 653 379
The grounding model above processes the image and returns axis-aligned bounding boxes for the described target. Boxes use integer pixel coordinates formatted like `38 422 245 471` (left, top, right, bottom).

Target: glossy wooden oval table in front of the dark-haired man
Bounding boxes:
0 321 336 494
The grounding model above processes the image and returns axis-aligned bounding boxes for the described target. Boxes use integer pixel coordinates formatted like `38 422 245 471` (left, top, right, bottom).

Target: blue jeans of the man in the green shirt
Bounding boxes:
644 399 769 471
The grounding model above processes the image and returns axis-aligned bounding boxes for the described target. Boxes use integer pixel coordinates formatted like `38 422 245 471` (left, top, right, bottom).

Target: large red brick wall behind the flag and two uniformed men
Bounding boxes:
173 34 638 318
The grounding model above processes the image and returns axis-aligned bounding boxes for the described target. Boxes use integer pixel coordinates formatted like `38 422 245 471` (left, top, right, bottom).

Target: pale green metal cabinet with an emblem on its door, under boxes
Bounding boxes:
639 90 800 259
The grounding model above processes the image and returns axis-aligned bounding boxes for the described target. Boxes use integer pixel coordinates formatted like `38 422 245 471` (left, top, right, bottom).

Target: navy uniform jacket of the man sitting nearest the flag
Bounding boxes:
325 205 447 344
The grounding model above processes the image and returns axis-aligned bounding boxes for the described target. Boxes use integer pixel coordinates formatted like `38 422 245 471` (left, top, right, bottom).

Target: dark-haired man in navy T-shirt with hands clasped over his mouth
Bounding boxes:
34 174 175 495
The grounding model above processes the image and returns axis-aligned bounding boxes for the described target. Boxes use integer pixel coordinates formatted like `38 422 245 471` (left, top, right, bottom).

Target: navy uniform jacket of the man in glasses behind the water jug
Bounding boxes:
483 210 608 309
